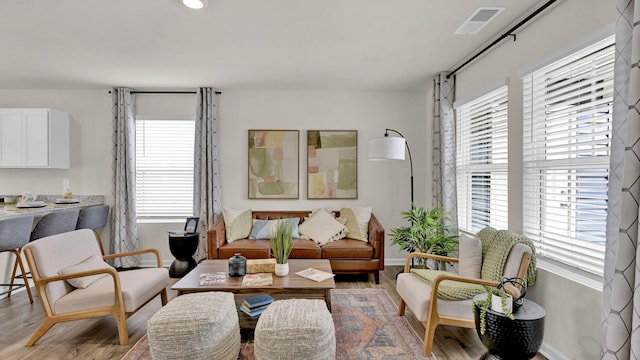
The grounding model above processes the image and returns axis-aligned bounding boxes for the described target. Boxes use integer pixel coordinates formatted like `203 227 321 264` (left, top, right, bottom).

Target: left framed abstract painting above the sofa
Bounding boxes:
249 130 300 199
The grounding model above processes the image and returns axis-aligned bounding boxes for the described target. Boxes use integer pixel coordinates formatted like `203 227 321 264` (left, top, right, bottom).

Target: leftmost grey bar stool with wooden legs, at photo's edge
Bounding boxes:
0 216 33 304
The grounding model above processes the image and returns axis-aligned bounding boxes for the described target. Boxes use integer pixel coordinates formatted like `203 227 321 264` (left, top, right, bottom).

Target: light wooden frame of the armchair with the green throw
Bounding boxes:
398 252 531 356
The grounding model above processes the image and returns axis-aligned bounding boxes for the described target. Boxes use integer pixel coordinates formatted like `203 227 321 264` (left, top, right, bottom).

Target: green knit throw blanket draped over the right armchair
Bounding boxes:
411 227 536 300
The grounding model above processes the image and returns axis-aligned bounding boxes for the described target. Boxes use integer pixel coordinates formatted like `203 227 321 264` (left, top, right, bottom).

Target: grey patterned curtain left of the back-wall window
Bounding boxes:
111 88 140 268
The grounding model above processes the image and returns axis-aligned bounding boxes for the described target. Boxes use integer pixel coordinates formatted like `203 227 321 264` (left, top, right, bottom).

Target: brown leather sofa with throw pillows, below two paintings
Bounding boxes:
207 211 384 284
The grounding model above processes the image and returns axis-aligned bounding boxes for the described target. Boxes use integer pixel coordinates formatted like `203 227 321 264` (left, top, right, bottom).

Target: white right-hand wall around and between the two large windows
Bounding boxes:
456 0 615 359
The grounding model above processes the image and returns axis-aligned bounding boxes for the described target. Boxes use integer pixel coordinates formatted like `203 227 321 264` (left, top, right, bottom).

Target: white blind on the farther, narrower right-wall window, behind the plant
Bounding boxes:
456 86 508 233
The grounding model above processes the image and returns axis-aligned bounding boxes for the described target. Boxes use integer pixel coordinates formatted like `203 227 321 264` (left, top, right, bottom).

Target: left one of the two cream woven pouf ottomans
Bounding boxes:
147 292 240 360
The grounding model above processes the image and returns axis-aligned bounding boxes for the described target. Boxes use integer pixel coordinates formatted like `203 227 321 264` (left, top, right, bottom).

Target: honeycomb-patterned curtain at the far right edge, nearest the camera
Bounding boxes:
602 0 640 360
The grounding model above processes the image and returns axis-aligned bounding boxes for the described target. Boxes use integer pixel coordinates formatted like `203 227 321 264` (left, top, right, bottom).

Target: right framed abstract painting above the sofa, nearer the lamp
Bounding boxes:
307 130 358 199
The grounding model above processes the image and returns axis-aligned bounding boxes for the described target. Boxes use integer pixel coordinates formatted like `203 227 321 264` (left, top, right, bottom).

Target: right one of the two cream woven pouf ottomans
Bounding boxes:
253 299 336 360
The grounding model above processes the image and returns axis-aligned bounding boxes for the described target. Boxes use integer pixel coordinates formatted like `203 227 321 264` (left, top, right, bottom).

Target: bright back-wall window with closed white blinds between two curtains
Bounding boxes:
136 117 195 219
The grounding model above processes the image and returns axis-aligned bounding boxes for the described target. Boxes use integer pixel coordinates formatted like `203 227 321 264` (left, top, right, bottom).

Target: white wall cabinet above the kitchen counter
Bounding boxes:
0 109 70 169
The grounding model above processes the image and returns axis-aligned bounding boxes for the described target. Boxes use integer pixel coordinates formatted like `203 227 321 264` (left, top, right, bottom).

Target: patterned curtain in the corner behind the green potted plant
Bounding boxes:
432 73 458 229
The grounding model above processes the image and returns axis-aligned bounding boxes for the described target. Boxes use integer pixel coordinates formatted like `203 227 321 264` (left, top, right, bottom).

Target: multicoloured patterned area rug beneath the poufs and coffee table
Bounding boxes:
122 289 435 360
